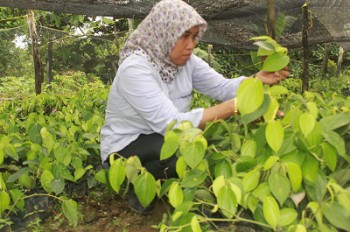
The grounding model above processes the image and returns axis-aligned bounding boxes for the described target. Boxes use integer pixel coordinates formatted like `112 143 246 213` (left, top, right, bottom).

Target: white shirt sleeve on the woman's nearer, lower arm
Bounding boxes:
117 58 204 134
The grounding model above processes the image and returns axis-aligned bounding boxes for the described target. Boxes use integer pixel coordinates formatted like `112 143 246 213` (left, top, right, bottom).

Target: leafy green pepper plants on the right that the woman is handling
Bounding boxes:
108 37 350 232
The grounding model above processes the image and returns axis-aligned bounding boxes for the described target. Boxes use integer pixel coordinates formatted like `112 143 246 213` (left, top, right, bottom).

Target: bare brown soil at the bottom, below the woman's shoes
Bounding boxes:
43 193 169 232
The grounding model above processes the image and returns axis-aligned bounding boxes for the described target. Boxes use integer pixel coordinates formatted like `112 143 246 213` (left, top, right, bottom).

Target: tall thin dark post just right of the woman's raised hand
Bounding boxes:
301 3 309 93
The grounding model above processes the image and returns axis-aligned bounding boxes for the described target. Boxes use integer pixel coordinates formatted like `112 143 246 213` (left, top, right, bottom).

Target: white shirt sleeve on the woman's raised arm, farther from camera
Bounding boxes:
192 55 247 101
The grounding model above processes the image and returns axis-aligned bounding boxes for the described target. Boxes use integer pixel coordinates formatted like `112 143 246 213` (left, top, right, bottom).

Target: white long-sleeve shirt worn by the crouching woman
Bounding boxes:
101 55 245 161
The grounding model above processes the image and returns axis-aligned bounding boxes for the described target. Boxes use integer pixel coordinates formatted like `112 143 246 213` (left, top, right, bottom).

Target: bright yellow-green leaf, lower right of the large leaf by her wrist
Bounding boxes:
265 121 284 153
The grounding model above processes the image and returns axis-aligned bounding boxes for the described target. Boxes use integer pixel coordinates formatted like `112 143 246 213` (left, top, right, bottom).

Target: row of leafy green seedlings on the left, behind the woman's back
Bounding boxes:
0 73 108 228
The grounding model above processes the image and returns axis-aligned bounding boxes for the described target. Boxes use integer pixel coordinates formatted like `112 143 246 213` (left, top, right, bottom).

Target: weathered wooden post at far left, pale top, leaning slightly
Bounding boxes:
28 10 44 95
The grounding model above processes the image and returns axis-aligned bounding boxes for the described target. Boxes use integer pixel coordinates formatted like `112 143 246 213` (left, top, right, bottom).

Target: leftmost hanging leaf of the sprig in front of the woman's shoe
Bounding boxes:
108 158 126 193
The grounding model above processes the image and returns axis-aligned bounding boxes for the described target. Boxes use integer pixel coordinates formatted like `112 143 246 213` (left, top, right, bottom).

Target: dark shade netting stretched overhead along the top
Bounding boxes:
0 0 350 49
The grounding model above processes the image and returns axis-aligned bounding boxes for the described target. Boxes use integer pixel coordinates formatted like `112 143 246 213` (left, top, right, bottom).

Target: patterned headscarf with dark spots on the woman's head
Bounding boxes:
119 0 207 82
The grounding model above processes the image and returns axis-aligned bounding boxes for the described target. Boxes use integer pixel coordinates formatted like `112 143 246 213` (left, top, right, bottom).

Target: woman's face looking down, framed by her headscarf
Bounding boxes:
170 26 199 65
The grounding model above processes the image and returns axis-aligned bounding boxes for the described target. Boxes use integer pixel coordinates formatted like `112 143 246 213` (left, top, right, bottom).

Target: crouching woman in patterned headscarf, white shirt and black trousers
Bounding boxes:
101 0 288 214
